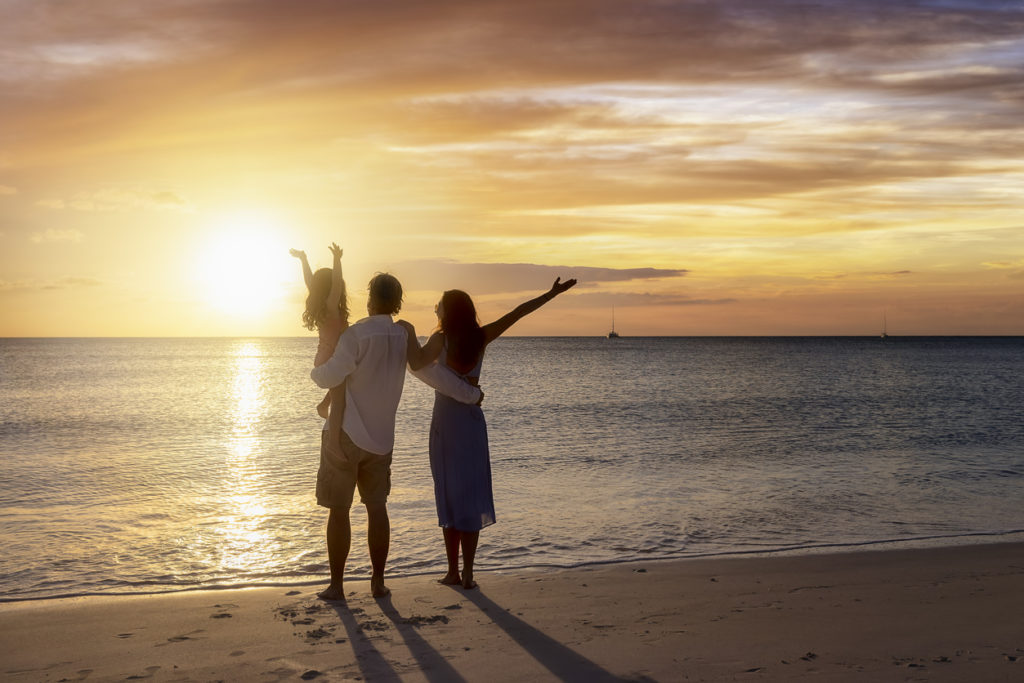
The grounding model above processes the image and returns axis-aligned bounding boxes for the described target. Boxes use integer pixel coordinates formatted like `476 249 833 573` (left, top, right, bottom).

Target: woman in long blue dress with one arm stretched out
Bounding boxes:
400 278 577 589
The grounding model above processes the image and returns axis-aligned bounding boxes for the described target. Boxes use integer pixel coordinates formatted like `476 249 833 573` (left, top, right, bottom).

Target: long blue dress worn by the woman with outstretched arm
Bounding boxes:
430 351 495 531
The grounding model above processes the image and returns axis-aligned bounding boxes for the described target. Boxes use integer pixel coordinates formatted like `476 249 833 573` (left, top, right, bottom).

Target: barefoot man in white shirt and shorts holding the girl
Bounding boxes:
310 273 482 600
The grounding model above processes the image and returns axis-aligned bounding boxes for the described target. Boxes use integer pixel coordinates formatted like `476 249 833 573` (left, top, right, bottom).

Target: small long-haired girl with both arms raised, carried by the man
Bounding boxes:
289 242 348 420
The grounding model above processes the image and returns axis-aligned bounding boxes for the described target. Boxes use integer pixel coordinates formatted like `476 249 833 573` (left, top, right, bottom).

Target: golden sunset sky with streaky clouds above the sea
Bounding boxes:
0 0 1024 337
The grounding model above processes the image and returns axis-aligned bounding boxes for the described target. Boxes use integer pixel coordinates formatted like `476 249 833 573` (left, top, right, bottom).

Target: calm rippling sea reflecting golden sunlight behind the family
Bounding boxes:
0 338 1024 600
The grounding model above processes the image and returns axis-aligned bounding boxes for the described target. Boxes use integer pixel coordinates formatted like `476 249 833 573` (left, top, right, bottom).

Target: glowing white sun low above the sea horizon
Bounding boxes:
197 212 295 317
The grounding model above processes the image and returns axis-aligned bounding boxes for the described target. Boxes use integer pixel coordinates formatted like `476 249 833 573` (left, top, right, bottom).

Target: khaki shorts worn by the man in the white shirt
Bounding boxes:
316 429 391 510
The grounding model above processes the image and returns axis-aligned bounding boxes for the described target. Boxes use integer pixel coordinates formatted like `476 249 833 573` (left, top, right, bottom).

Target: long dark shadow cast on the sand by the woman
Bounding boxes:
458 589 630 683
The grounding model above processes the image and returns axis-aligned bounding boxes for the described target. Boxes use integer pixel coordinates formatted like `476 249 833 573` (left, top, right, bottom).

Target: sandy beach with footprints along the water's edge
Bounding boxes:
0 544 1024 681
